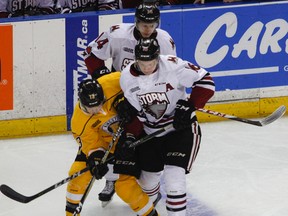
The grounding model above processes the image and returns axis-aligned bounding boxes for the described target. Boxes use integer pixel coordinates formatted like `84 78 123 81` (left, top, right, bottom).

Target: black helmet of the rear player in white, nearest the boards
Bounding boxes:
135 3 160 25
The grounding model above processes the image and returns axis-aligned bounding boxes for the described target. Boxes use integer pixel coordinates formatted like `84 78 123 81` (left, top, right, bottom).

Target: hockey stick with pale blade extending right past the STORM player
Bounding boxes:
197 105 286 127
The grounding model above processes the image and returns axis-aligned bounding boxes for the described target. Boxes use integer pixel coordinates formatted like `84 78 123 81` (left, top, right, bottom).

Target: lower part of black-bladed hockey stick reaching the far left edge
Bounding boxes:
0 167 89 203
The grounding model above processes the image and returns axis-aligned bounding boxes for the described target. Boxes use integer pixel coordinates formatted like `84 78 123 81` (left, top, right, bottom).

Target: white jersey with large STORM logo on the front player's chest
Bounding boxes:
120 55 215 136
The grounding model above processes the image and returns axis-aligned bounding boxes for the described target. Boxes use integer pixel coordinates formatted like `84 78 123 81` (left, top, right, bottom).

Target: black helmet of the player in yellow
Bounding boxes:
78 79 104 107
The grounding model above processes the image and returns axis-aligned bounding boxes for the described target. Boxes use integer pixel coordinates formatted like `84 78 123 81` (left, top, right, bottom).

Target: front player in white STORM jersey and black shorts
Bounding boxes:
114 39 215 216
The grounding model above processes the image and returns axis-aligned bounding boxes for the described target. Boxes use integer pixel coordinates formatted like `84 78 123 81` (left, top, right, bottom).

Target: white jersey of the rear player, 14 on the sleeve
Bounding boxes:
88 23 176 71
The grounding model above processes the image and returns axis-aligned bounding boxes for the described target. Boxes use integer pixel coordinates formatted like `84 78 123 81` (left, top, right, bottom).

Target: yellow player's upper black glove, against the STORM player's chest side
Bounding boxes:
113 94 137 123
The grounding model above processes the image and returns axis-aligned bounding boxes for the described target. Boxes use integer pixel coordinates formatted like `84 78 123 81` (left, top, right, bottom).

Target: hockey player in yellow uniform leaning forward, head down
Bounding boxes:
66 72 158 216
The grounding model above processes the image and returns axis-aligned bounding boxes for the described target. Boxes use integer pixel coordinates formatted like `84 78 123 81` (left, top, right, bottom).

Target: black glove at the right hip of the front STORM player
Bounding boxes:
173 100 197 130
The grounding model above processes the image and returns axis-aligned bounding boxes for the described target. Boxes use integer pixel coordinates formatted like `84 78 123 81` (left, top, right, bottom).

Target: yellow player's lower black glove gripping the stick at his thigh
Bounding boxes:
87 150 108 180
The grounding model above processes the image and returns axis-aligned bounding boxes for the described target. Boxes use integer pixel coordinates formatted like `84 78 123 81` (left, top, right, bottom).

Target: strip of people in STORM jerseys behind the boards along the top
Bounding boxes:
0 0 280 18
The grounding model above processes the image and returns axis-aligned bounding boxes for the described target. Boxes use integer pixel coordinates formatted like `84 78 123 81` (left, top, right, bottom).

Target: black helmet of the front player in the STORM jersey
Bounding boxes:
135 38 160 61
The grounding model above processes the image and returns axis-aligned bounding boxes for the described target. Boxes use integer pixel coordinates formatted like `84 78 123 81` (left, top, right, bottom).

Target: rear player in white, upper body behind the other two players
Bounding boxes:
84 3 176 78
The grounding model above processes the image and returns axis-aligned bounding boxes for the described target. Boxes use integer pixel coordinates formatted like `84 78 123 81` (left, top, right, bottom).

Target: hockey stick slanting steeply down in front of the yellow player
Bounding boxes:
73 121 124 216
